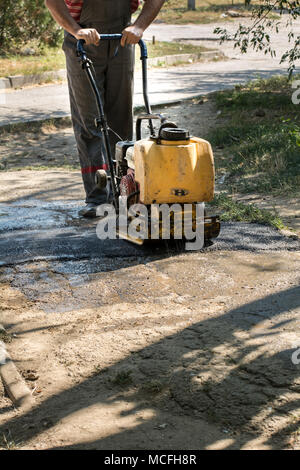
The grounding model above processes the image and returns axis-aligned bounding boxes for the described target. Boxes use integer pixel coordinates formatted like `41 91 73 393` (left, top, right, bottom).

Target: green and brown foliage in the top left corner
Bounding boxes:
0 0 62 55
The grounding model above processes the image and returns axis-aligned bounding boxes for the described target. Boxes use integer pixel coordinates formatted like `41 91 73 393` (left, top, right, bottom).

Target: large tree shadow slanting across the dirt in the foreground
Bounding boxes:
0 287 300 449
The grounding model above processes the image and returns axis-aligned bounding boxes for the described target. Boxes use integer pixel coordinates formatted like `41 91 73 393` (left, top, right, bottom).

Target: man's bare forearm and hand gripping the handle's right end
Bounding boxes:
121 0 165 46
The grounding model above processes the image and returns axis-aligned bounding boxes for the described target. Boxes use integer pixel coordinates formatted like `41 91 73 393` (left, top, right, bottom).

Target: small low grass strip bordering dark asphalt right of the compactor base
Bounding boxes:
210 193 285 230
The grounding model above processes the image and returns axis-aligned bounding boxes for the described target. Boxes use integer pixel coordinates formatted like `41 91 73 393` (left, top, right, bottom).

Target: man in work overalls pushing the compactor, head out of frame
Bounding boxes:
45 0 165 217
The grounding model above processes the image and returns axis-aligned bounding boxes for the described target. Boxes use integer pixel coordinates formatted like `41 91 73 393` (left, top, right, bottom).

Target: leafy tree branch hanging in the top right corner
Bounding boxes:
215 0 300 75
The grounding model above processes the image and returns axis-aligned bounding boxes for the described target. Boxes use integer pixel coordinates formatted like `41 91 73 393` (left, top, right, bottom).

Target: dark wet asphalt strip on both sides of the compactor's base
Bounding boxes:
0 199 300 266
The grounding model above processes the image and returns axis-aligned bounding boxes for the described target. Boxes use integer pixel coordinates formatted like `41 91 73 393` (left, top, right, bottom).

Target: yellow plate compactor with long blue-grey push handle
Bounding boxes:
77 34 220 244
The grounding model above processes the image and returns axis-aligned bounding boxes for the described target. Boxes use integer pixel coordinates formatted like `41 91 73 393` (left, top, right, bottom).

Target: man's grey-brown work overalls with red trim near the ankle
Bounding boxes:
63 0 134 204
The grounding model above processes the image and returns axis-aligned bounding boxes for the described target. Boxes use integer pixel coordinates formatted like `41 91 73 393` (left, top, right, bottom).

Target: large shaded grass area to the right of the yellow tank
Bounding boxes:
208 77 300 196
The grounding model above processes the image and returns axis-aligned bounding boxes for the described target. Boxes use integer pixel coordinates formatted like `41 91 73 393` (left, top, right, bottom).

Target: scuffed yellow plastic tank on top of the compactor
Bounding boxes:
133 129 215 204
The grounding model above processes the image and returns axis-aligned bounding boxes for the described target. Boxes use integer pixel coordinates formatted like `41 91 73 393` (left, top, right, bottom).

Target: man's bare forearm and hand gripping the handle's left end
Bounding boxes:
45 0 100 45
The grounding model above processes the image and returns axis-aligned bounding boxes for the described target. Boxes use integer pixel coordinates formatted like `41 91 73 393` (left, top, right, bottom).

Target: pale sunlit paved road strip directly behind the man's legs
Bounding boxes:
0 60 284 126
